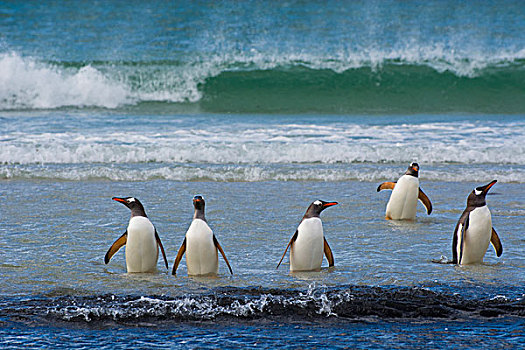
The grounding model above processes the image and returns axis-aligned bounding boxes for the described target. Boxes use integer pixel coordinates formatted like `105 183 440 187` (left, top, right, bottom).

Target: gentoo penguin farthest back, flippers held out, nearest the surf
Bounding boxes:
377 163 432 220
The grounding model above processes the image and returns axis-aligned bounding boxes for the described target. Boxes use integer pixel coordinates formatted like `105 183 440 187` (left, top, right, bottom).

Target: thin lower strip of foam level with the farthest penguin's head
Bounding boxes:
0 164 525 183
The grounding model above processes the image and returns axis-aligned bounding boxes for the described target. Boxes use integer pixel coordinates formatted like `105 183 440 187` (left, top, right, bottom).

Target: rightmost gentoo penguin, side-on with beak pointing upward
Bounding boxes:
452 180 503 265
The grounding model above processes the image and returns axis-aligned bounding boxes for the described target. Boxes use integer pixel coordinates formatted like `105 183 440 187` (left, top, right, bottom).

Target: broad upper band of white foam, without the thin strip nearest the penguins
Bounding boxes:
0 122 525 166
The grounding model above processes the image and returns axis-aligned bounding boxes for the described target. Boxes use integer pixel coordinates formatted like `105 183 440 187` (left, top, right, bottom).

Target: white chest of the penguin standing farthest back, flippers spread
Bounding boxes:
385 175 419 220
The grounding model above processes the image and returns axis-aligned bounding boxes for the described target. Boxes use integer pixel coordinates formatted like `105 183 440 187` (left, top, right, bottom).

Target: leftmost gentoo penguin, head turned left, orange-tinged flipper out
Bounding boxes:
104 197 168 272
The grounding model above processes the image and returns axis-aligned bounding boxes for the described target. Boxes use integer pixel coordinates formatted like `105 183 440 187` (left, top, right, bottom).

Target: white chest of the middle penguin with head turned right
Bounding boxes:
290 217 324 271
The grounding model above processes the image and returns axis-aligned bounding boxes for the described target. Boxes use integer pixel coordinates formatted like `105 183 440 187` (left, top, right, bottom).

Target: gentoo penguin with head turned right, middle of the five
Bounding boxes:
277 200 338 271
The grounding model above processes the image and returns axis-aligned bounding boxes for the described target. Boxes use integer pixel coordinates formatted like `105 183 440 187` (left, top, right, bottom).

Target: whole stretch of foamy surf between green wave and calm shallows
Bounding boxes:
0 116 525 183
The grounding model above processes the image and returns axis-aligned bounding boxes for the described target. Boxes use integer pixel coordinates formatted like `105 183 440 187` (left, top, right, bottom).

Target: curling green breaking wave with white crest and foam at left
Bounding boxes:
0 48 525 114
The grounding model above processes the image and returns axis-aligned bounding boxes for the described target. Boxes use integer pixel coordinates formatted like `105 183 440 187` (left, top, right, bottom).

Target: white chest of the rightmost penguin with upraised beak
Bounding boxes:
458 205 492 264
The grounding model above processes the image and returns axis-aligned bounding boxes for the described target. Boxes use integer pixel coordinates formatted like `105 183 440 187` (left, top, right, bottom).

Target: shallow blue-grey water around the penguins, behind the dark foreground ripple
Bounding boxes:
1 180 525 295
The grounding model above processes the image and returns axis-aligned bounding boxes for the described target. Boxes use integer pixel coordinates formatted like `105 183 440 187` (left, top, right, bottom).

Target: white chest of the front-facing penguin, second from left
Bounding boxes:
186 219 219 275
